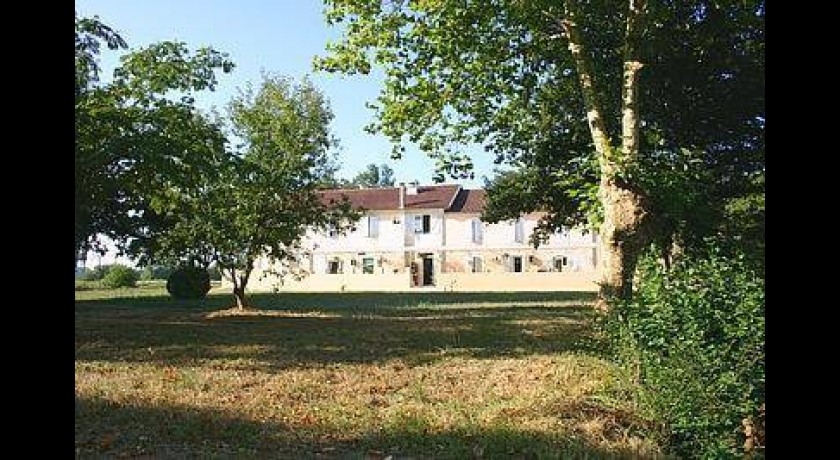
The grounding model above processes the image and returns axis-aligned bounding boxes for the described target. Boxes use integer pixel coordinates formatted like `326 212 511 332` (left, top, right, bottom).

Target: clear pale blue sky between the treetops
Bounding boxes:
76 0 493 187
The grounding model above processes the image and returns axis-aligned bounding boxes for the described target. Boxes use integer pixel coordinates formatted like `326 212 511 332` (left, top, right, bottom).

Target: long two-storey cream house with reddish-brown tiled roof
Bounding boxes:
243 184 598 292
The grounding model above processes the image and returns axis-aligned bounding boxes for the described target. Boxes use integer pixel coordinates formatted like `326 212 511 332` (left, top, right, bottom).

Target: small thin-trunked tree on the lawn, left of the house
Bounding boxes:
152 75 358 309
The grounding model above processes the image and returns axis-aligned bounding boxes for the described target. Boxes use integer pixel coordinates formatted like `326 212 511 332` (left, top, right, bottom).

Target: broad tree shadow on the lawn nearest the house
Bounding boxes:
76 293 601 370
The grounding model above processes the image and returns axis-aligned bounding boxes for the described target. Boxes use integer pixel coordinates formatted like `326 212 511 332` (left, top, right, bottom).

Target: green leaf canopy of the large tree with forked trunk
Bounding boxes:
316 0 765 252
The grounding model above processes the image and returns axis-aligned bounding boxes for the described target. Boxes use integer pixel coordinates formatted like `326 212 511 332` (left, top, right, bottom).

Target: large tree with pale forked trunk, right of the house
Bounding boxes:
316 0 764 306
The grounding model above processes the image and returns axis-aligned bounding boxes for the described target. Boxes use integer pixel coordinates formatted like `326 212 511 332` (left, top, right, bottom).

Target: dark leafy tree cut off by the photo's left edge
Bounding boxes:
74 13 233 262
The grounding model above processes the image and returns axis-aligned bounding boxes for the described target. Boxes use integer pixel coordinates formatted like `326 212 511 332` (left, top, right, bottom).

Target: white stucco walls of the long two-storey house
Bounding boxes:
249 204 597 290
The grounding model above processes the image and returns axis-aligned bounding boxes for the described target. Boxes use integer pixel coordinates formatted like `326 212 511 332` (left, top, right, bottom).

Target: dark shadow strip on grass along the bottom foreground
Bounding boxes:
75 396 656 460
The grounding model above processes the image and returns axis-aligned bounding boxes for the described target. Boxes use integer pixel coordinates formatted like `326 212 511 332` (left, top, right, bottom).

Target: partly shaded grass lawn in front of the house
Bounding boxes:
75 285 658 459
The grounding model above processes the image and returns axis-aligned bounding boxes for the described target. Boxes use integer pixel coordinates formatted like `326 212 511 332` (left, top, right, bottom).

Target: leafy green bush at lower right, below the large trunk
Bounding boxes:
604 244 765 458
